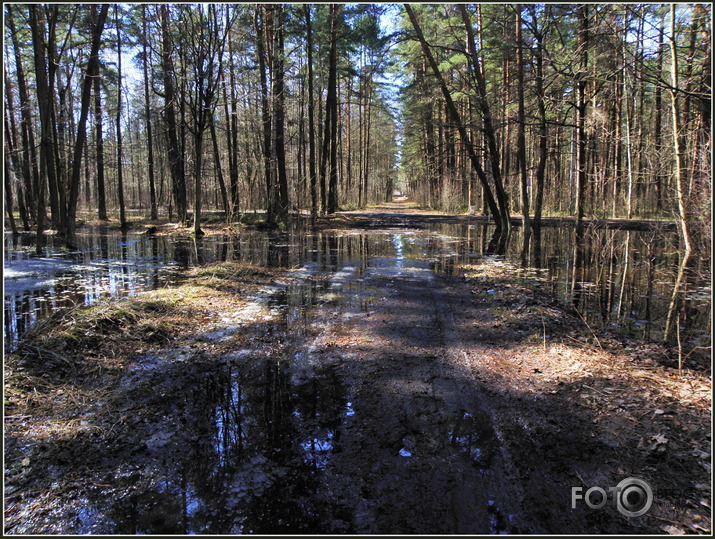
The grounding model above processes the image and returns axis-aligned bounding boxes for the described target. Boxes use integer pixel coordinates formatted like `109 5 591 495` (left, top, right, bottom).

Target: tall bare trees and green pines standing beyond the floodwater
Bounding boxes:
4 4 712 252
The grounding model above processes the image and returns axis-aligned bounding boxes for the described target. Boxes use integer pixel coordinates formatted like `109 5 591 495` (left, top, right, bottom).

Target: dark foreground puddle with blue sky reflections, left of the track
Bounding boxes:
92 357 348 534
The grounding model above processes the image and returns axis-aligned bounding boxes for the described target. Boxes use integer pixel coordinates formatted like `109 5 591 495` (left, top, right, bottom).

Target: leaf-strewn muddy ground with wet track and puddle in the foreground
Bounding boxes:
4 203 712 534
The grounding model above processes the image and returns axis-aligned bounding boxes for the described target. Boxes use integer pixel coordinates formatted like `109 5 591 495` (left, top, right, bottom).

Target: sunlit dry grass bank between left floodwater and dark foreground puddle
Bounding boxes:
4 262 282 416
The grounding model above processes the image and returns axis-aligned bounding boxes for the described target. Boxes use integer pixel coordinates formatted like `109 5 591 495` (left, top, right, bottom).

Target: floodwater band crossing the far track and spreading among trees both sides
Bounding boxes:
4 219 712 349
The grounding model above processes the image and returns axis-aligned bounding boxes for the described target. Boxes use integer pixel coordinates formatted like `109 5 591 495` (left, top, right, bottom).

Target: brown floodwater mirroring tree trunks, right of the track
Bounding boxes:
465 225 711 345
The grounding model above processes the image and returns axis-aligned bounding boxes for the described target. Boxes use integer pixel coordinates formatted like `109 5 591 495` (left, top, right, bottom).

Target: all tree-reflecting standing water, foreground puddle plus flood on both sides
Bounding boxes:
4 220 710 534
